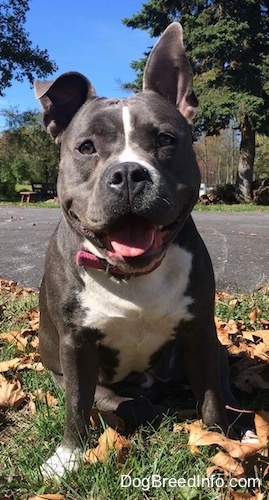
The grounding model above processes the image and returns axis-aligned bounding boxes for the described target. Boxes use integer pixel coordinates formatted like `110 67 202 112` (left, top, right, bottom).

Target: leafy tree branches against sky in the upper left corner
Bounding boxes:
0 0 57 95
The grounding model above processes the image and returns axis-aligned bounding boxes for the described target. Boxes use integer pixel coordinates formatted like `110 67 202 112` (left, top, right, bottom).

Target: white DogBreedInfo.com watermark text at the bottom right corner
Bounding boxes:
120 474 261 491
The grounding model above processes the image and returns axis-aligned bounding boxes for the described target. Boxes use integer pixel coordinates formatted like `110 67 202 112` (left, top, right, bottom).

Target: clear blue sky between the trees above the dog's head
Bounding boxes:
0 0 154 129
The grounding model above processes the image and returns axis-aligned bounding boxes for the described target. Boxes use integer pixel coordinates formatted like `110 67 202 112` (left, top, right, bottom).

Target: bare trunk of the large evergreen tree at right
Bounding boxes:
236 115 255 203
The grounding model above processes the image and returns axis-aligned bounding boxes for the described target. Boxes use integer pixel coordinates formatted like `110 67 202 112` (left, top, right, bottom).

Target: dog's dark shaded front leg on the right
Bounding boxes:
182 322 228 432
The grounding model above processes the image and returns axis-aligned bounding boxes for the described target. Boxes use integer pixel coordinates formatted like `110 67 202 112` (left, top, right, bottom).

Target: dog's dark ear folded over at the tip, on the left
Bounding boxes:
34 72 96 143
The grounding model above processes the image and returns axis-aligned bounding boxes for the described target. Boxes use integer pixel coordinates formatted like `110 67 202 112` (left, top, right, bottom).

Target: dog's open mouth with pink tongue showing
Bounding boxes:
70 212 183 274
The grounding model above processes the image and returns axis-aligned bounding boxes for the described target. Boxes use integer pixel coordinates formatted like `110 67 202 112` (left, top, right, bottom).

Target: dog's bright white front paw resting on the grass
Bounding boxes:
41 445 83 479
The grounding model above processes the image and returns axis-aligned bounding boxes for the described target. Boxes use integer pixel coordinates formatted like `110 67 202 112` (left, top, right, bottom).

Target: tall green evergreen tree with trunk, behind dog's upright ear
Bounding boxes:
123 0 269 202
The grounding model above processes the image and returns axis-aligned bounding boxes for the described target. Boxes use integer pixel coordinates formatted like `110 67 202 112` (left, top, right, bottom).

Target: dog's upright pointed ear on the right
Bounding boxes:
143 23 198 125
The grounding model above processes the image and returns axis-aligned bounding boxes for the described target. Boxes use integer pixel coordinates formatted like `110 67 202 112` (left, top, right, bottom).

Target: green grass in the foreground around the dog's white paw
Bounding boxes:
0 405 216 500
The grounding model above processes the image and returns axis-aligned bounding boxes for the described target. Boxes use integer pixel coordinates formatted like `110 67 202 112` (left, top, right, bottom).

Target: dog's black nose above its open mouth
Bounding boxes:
107 162 152 200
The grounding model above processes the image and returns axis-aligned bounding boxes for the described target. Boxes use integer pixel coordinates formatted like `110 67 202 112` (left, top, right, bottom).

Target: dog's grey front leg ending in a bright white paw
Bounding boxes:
42 331 99 477
